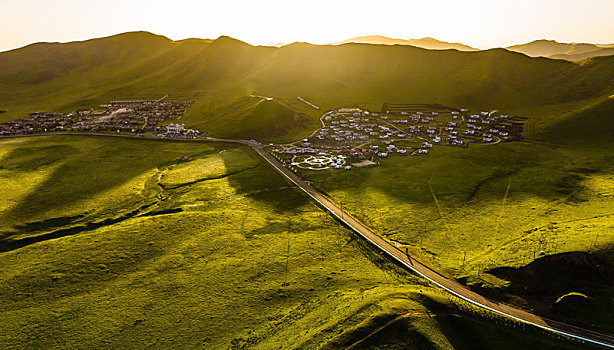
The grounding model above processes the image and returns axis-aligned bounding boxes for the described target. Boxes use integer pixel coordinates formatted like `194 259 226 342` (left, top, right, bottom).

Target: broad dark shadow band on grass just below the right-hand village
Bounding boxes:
308 137 614 210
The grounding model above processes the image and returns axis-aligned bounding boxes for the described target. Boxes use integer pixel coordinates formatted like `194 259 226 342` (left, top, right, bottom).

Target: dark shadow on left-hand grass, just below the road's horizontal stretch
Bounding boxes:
0 136 212 239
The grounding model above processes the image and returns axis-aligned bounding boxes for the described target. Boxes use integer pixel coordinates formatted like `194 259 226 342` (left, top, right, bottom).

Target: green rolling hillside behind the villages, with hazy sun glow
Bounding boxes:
0 32 614 140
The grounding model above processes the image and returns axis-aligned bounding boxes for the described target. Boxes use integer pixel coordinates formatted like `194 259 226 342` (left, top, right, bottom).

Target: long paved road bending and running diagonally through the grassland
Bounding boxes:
0 133 614 349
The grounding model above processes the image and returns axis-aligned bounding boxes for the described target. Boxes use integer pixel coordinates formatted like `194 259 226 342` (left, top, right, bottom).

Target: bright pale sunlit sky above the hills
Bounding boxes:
0 0 614 51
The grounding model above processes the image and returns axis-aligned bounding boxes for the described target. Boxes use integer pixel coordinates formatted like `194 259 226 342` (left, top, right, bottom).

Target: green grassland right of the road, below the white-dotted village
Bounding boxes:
308 99 614 330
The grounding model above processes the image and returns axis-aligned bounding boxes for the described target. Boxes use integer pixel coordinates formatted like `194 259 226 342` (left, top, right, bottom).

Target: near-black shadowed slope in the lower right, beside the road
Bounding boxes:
483 245 614 333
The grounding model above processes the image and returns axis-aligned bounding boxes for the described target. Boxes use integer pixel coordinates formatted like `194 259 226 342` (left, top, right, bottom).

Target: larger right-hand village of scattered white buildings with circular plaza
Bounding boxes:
268 103 526 171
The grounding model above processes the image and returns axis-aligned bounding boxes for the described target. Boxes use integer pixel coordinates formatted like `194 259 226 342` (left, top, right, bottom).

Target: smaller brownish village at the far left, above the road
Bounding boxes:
0 98 200 138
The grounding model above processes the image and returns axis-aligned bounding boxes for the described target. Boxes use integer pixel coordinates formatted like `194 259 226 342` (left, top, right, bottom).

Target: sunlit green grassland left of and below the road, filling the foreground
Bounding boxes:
0 136 596 349
